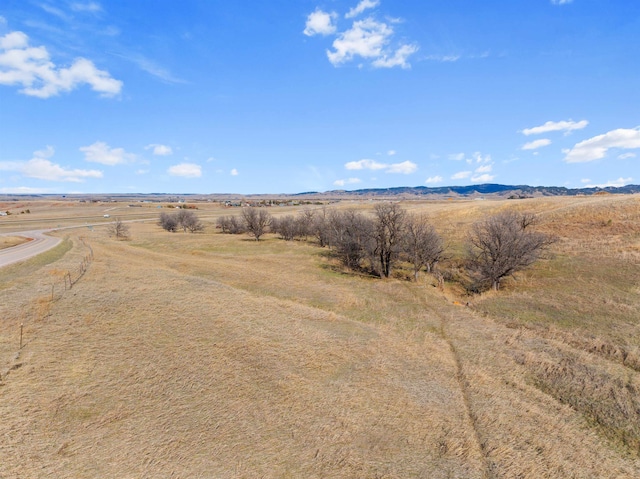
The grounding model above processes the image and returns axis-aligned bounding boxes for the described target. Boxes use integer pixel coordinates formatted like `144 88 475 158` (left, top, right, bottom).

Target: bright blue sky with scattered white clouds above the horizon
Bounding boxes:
0 0 640 194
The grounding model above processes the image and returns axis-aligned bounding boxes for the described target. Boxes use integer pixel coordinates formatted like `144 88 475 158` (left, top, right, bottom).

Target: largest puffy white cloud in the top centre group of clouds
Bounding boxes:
327 18 418 68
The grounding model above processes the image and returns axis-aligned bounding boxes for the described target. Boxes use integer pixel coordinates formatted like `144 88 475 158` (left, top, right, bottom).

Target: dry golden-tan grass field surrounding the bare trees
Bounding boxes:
0 196 640 478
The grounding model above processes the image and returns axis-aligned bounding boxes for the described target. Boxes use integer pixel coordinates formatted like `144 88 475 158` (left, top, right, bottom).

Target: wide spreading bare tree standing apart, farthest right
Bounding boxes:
467 211 555 291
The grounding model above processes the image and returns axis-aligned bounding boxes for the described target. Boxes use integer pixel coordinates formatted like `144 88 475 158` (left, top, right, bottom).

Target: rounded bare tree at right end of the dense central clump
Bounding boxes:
402 215 445 281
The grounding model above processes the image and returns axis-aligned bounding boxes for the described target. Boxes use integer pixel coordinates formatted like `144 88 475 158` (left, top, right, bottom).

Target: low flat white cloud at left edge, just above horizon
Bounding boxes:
0 146 102 183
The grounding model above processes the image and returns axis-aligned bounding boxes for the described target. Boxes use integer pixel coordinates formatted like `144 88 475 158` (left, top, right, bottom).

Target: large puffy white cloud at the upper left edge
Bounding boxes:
0 31 122 98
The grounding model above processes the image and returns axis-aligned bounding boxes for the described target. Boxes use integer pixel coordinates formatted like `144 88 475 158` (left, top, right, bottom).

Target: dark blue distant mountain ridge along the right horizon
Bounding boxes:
306 183 640 198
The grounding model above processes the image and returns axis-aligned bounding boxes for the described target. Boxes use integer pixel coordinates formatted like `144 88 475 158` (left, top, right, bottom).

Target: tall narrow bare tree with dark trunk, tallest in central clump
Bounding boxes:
373 203 406 278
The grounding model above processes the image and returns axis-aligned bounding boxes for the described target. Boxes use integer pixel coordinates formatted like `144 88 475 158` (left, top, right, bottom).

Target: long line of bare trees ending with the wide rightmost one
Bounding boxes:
210 203 555 290
